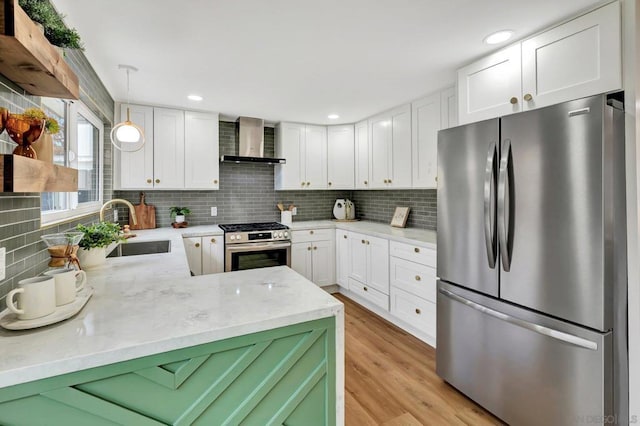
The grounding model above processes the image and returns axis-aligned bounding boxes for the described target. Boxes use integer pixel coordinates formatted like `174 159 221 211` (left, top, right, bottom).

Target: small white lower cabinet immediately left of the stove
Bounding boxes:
182 235 224 275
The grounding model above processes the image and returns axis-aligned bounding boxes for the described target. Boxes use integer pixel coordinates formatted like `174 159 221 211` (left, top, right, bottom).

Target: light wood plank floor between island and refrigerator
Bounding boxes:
334 294 502 426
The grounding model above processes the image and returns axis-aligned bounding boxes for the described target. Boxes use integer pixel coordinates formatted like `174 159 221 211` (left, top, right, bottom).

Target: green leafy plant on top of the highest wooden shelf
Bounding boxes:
18 0 83 50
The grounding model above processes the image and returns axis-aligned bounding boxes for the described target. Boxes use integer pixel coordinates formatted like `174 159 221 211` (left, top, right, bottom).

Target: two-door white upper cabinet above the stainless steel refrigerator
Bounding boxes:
458 2 622 124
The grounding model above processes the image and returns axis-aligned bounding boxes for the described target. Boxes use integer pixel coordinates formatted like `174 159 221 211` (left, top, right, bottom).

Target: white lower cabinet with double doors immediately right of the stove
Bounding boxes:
291 229 336 287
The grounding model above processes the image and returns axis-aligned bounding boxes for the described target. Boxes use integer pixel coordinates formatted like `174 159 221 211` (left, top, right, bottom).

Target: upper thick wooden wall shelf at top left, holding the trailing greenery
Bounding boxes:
0 0 80 99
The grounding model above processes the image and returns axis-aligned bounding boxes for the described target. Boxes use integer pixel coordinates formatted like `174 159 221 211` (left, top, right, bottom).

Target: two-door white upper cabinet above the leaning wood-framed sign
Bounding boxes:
369 104 411 189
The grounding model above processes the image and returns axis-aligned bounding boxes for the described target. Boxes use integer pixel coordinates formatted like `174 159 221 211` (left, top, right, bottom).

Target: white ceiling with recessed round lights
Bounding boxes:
52 0 602 124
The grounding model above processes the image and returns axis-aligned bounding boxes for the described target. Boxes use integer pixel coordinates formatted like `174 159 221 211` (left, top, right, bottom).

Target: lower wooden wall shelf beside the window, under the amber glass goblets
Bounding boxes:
0 155 78 192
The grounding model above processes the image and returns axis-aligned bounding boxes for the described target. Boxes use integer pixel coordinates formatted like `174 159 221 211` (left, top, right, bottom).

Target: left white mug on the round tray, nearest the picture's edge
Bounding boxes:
6 277 56 320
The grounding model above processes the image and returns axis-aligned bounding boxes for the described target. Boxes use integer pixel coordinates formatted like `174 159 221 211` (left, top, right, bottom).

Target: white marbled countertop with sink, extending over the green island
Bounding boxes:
0 226 343 388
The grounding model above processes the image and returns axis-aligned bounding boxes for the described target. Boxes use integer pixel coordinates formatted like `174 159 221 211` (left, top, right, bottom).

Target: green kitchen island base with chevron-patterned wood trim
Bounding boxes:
0 317 336 426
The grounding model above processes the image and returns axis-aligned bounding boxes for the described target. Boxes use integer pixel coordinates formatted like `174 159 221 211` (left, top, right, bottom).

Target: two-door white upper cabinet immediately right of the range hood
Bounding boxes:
274 123 327 190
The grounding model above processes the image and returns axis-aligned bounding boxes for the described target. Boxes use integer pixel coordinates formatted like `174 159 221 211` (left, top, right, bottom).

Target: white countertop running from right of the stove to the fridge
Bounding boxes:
289 220 437 249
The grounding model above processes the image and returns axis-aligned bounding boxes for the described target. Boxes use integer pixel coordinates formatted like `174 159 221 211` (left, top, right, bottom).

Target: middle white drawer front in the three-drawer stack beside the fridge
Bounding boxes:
390 257 437 303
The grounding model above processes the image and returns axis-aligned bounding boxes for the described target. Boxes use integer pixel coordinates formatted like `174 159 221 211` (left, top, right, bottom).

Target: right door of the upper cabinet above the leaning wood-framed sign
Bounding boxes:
387 104 411 188
